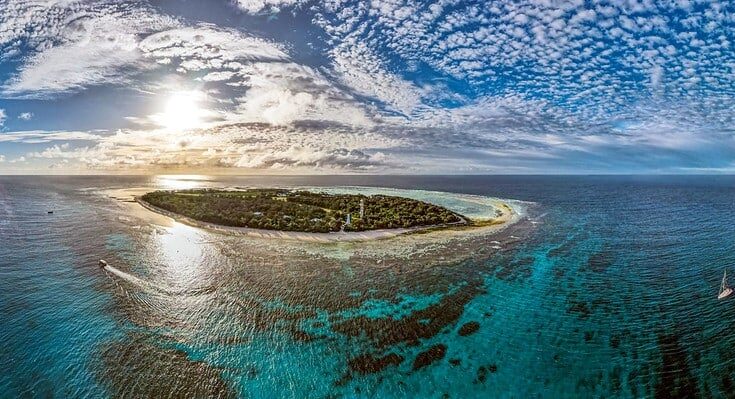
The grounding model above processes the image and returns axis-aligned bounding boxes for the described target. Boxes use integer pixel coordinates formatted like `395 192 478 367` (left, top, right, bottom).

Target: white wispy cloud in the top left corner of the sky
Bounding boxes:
0 2 177 98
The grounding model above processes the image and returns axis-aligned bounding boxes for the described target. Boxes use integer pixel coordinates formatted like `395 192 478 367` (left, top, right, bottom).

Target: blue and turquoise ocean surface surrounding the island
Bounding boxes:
0 176 735 398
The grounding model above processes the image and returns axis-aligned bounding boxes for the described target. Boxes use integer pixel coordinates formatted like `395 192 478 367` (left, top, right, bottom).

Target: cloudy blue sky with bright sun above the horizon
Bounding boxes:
0 0 735 174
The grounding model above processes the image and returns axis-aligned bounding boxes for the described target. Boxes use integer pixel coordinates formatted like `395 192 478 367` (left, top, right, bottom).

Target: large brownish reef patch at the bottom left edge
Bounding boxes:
98 337 237 398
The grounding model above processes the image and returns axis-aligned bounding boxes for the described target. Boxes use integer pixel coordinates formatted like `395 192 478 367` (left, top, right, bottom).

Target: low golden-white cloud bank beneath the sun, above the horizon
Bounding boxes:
15 122 404 170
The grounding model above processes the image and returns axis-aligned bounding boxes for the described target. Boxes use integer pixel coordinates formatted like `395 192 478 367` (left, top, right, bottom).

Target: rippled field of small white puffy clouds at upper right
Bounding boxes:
315 0 735 122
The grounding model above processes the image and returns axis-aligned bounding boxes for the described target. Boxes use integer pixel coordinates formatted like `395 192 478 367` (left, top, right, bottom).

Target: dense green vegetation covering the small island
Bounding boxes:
141 189 465 232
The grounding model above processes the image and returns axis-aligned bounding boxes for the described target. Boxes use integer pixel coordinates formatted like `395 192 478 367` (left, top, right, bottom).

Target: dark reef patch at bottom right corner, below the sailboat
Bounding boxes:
655 334 699 398
